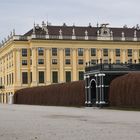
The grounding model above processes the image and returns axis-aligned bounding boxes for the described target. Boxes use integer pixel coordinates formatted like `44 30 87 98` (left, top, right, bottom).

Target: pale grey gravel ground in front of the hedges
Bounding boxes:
0 104 140 140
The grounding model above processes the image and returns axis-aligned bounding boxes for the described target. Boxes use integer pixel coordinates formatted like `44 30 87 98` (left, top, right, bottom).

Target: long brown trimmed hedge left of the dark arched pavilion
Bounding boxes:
14 81 85 106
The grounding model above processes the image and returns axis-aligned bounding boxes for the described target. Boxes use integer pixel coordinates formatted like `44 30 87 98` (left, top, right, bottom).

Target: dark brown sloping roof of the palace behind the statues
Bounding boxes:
23 25 140 40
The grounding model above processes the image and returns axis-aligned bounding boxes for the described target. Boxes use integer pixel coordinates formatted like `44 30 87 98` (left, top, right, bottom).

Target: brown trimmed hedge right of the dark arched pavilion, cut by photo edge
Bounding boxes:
109 73 140 108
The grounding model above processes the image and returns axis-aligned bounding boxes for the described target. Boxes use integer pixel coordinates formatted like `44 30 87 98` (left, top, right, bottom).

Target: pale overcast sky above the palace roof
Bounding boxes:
0 0 140 40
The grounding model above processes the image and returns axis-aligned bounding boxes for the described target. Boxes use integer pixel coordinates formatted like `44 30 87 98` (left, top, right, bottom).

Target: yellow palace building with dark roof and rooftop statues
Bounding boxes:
0 22 140 103
